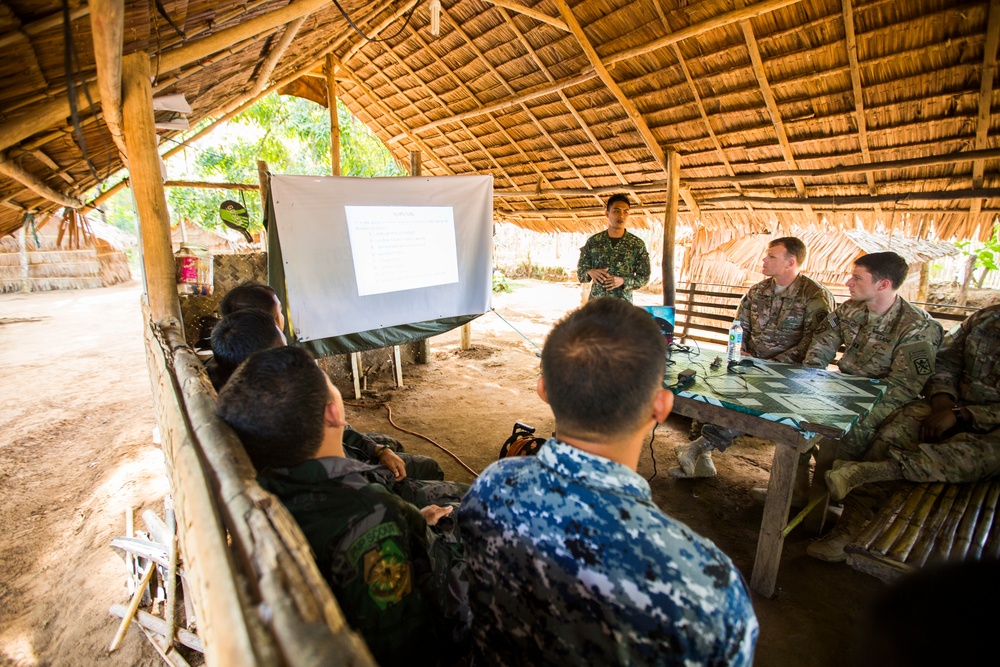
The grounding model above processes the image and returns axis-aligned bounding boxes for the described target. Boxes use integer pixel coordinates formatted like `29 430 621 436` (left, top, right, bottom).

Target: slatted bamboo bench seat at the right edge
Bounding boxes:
845 480 1000 582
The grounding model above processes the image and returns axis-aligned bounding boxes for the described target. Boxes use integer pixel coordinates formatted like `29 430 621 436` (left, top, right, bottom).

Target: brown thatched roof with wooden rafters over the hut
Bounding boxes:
0 0 1000 238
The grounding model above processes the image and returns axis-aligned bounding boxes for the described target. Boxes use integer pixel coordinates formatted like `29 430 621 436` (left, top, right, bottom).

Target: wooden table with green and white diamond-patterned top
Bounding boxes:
663 352 887 597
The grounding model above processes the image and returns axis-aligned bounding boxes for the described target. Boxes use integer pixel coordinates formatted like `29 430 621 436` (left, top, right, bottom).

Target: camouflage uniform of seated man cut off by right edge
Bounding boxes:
866 305 1000 482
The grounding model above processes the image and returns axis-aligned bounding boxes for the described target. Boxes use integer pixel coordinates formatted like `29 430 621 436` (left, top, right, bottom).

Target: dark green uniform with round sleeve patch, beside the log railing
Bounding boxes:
258 457 471 666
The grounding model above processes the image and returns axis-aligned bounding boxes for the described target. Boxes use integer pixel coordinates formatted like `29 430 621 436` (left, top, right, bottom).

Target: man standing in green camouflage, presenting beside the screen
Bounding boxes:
576 194 649 303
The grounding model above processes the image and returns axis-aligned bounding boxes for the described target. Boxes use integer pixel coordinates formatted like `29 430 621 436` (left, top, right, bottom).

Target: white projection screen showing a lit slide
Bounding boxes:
271 175 493 341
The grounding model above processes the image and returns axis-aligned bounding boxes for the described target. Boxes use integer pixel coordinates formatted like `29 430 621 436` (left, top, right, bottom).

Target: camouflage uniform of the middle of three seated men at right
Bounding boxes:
803 296 943 460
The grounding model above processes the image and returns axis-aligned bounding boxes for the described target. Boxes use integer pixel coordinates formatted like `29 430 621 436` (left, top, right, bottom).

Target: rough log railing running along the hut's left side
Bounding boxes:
144 309 375 667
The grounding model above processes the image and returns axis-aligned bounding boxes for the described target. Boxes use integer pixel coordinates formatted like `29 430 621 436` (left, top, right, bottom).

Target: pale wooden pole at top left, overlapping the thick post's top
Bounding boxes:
90 0 128 160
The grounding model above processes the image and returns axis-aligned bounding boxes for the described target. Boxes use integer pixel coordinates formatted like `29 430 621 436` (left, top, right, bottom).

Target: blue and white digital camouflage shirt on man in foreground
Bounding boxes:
459 439 758 666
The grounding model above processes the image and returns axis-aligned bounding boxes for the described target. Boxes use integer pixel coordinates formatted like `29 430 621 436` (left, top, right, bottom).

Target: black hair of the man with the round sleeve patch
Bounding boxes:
218 347 330 472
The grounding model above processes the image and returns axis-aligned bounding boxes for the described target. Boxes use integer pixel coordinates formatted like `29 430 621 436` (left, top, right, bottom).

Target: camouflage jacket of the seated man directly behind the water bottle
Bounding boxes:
736 274 834 364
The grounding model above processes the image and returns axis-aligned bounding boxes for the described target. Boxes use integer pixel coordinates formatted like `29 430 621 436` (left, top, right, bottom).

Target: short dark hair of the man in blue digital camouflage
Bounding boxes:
542 297 667 437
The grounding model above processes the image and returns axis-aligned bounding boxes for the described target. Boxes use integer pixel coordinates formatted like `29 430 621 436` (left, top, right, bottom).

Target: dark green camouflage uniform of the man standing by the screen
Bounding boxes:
576 230 649 303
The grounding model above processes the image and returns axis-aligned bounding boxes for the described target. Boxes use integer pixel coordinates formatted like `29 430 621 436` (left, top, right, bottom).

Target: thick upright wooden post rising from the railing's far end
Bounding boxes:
122 51 181 322
